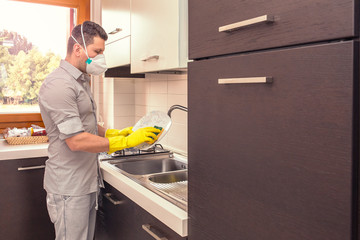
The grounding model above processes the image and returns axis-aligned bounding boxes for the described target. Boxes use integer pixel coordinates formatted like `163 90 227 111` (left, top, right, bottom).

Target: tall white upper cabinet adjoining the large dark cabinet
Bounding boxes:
131 0 188 73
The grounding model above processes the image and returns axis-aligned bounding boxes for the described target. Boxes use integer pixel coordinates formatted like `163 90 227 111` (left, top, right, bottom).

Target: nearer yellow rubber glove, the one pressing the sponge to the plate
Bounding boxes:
108 127 160 154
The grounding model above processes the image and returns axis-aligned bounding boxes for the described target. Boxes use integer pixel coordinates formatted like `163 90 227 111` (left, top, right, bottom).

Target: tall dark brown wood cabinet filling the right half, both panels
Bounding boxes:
188 0 360 240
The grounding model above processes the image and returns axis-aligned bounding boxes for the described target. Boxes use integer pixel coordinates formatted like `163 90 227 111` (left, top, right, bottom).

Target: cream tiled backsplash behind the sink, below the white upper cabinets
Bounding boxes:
93 73 188 153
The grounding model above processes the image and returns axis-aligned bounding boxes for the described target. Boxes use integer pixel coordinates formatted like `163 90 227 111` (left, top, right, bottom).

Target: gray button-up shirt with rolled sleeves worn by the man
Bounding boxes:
39 60 98 196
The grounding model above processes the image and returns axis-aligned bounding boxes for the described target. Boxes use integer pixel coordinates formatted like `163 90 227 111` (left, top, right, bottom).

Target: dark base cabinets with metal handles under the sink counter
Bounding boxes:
95 182 186 240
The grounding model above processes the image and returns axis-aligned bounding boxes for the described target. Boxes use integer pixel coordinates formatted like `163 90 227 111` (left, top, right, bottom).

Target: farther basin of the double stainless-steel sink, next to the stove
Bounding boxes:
111 158 187 175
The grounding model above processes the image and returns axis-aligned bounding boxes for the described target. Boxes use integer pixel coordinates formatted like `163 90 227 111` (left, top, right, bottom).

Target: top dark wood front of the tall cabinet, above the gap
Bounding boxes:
189 0 358 59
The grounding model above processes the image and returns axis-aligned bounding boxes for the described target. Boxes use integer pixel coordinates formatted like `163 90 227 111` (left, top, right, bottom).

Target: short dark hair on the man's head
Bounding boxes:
67 21 108 54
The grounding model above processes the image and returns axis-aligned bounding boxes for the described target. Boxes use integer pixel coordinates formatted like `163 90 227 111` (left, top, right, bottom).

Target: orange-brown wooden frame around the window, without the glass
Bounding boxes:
0 0 90 133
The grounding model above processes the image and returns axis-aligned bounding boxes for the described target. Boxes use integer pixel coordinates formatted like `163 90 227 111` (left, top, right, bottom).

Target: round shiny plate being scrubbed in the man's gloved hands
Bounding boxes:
133 111 171 149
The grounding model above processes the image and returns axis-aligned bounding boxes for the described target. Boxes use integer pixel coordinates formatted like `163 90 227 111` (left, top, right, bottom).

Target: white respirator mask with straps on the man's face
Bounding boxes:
71 25 107 76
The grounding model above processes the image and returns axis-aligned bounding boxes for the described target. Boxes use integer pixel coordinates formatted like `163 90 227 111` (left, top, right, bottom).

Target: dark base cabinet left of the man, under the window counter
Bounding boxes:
0 157 55 240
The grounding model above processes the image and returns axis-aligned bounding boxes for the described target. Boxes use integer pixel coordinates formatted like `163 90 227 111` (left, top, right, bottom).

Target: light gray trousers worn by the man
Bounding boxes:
46 192 97 240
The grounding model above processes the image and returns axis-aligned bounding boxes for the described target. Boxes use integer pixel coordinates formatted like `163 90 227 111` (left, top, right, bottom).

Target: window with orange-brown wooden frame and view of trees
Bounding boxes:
0 0 90 132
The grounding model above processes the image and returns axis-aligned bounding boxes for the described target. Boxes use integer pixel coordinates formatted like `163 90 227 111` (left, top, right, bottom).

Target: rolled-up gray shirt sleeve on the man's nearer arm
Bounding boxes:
41 78 84 140
